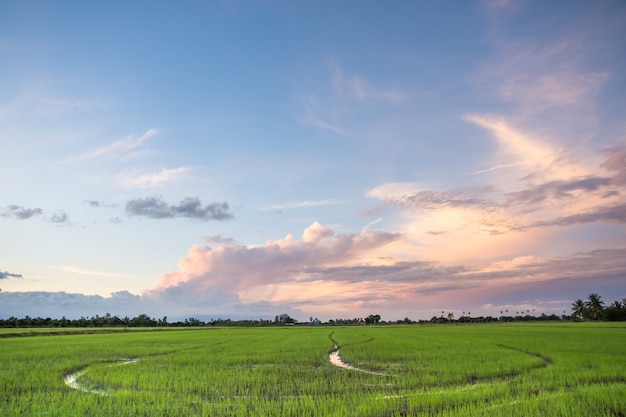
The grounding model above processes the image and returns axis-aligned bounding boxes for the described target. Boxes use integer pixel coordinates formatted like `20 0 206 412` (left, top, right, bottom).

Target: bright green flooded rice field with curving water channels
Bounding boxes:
0 323 626 417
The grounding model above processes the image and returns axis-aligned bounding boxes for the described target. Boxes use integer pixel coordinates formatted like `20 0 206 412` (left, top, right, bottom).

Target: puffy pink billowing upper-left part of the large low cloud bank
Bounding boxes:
157 223 401 293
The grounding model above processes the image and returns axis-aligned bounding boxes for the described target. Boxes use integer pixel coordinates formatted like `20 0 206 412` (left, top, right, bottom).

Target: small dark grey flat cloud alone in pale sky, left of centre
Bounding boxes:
126 197 234 221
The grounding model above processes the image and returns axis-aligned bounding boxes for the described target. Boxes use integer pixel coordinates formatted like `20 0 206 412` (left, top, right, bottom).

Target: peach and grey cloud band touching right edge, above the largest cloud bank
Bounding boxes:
364 143 626 233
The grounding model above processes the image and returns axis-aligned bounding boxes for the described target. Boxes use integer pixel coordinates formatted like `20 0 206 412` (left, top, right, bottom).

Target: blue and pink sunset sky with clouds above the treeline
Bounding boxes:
0 0 626 321
